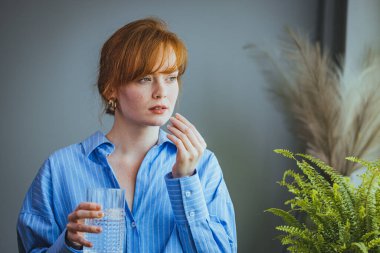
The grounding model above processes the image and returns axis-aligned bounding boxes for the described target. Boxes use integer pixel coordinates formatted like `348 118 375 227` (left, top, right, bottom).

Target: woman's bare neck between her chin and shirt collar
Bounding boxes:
106 115 160 156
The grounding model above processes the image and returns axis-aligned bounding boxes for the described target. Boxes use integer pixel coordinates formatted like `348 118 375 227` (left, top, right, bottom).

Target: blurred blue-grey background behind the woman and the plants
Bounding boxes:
0 0 380 253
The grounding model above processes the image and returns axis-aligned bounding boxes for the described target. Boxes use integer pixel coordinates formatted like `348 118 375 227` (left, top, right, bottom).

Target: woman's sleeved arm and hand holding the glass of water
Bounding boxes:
17 159 102 253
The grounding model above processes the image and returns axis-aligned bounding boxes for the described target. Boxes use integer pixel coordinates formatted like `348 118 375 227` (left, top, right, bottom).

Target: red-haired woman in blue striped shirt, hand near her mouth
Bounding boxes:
17 18 237 253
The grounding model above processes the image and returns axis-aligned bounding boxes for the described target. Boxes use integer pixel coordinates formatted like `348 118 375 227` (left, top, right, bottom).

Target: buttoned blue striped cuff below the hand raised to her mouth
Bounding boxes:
165 170 209 224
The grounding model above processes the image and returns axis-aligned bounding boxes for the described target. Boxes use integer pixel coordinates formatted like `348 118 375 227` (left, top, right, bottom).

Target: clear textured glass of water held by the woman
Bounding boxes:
83 188 126 253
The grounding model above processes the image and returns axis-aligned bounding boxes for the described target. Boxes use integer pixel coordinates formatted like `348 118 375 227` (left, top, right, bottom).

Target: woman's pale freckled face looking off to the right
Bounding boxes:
115 51 179 126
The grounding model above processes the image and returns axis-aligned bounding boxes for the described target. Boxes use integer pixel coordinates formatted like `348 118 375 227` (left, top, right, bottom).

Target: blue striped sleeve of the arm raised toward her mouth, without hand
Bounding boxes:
165 153 237 252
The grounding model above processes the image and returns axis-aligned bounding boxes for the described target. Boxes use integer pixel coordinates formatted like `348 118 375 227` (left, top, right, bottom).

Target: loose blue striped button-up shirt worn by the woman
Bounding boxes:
17 129 237 253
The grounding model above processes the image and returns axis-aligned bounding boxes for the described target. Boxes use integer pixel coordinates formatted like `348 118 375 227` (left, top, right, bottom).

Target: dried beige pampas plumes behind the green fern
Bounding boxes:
245 29 380 175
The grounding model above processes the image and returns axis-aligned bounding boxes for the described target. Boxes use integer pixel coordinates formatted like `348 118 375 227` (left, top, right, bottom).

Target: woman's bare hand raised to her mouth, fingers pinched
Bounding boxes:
167 113 207 178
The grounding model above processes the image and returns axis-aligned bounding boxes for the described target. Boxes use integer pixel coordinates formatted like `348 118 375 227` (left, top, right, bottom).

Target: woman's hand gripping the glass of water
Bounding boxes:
66 202 104 247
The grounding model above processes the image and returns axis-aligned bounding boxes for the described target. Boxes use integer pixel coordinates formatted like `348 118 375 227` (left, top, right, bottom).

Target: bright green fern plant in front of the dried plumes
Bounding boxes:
266 149 380 253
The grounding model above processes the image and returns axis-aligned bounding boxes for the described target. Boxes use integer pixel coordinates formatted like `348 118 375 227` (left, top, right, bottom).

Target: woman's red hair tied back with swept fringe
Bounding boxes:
98 18 187 114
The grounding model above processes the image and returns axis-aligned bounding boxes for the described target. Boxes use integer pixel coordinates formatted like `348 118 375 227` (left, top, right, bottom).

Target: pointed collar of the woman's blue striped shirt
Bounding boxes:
82 128 174 157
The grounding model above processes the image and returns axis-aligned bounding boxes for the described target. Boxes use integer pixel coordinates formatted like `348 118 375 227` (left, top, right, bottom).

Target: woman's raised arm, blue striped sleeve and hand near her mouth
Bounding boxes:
165 114 237 252
